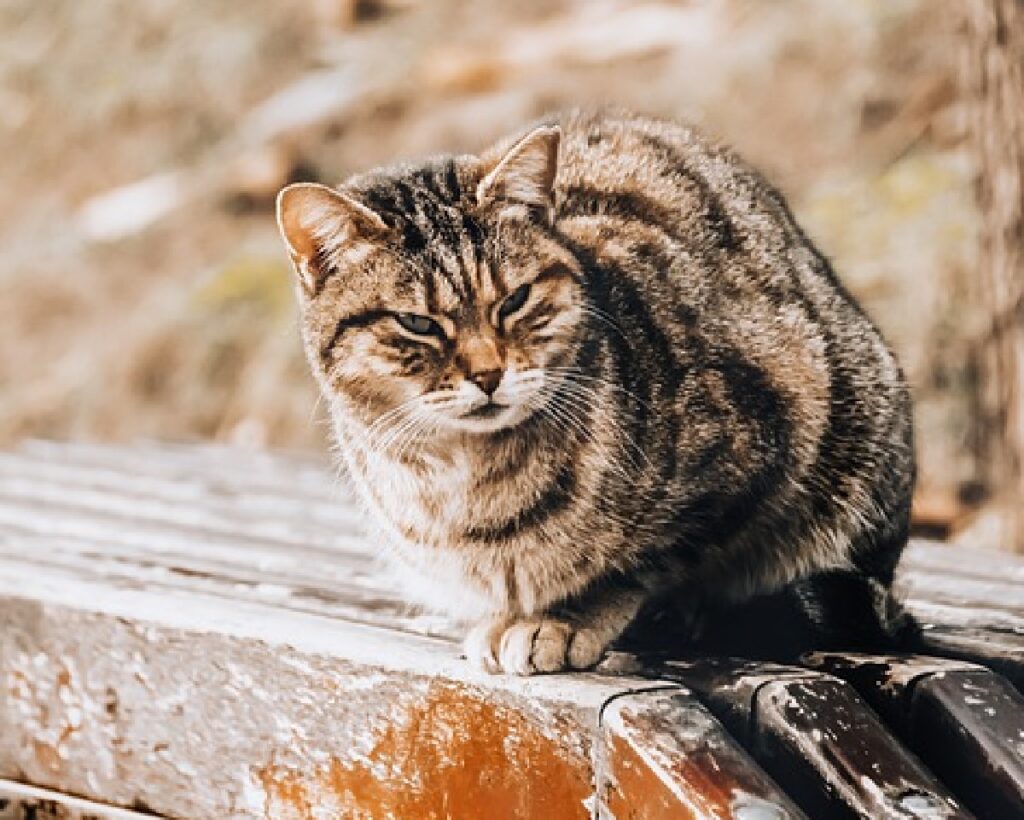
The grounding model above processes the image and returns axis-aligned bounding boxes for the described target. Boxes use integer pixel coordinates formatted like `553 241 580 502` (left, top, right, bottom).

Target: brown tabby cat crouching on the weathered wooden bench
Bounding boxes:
278 111 914 675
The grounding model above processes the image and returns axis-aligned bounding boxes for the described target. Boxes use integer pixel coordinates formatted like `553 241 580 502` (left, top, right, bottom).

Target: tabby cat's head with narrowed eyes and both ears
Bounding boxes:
278 127 584 439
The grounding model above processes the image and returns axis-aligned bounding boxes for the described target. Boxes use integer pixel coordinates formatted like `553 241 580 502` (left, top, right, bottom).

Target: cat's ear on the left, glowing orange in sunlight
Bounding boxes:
278 182 387 295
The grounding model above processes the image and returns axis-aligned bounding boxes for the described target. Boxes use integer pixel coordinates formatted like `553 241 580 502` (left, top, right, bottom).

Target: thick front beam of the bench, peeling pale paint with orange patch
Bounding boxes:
0 559 765 818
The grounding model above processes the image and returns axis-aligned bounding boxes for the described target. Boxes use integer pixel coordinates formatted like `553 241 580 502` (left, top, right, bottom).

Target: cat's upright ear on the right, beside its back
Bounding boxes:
476 125 562 219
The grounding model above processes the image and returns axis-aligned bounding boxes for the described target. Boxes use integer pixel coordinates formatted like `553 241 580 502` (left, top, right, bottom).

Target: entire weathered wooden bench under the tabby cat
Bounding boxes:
0 442 1024 820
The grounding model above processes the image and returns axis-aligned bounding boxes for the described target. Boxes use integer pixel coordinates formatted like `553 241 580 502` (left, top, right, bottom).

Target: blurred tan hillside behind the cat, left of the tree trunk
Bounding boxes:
0 0 1020 548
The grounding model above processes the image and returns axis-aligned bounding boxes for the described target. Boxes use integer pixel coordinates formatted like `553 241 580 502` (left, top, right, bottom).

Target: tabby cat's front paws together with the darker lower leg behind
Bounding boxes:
465 587 648 675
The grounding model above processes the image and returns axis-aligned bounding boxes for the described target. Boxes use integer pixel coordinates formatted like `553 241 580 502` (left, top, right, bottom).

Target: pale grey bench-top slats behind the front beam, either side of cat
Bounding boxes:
0 441 1024 638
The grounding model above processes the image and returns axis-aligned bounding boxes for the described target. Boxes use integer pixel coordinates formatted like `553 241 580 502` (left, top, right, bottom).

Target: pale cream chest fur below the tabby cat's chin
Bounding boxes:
345 425 572 619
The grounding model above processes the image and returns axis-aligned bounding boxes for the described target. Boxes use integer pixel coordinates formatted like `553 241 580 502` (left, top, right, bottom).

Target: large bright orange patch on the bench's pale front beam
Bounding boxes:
259 684 593 820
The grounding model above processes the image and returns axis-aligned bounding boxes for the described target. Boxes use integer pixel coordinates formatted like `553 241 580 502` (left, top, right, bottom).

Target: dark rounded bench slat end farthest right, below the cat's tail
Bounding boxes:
806 653 1024 818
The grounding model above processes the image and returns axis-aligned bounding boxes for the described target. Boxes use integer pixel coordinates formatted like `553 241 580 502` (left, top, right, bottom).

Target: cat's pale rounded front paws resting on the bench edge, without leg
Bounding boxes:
465 616 606 675
